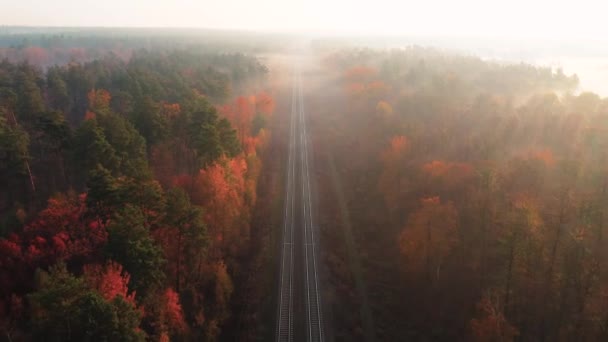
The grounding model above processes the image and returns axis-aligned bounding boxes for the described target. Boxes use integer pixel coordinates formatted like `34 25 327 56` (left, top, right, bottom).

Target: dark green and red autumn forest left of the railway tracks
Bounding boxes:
0 32 275 341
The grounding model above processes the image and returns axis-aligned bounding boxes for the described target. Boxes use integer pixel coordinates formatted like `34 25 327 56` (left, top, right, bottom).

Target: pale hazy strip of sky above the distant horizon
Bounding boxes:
0 0 608 38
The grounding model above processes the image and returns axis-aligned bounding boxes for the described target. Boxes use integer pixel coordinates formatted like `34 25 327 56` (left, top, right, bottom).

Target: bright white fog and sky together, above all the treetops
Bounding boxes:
0 0 608 95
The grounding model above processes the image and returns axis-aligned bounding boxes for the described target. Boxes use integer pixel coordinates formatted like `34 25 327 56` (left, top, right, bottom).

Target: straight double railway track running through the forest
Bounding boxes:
276 65 323 342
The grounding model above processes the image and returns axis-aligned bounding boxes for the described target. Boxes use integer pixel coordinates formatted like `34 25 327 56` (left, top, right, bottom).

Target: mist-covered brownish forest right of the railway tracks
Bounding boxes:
309 46 608 341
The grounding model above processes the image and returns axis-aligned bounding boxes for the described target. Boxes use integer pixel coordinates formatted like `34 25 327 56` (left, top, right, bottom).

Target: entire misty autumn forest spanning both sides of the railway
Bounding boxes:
0 26 608 342
